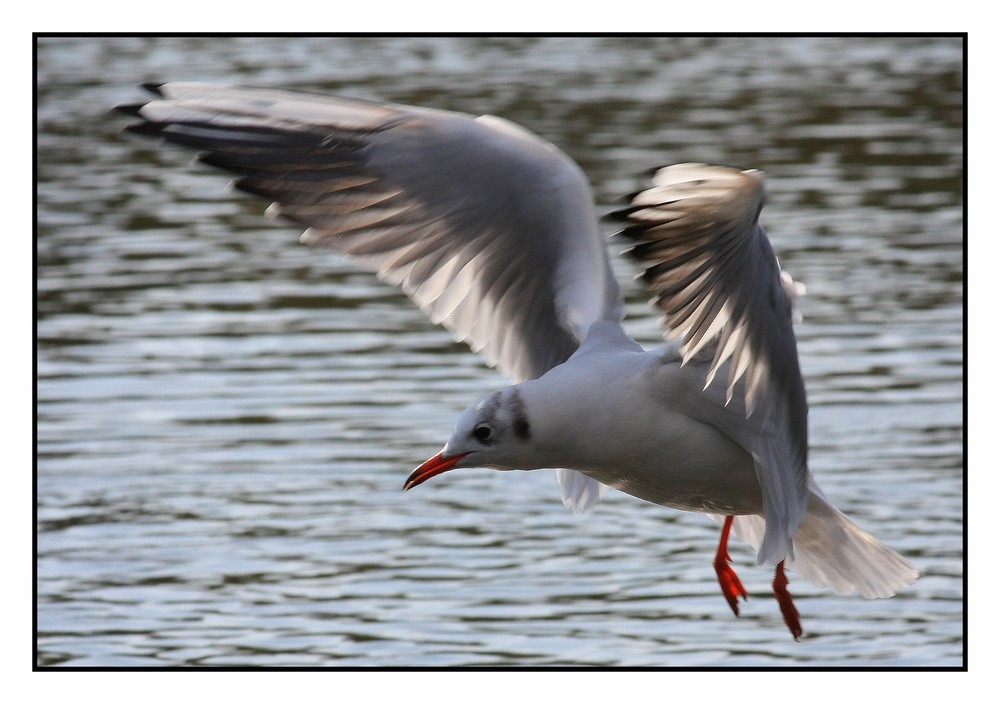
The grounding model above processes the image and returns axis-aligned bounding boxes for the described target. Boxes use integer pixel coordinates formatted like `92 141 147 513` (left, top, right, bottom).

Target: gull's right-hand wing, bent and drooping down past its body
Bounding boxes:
616 164 809 562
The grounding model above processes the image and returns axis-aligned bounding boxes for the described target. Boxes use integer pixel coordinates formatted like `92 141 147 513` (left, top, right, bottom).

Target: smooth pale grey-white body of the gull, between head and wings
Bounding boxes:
521 351 762 514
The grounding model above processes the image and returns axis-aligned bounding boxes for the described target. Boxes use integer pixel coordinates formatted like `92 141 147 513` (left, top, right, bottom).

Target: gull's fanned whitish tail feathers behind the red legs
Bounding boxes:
720 481 919 599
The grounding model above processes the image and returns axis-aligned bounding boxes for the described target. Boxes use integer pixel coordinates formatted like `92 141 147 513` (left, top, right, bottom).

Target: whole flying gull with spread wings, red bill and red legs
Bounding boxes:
118 83 918 640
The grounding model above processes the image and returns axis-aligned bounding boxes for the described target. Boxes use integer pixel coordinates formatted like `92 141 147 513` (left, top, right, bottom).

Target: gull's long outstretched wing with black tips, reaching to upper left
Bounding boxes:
119 83 622 381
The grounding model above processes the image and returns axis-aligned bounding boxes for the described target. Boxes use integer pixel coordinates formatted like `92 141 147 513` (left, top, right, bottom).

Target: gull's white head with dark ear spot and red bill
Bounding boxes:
403 386 539 491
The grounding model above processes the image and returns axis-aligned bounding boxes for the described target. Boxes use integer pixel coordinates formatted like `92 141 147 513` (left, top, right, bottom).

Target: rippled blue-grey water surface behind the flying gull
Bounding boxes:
37 37 964 667
